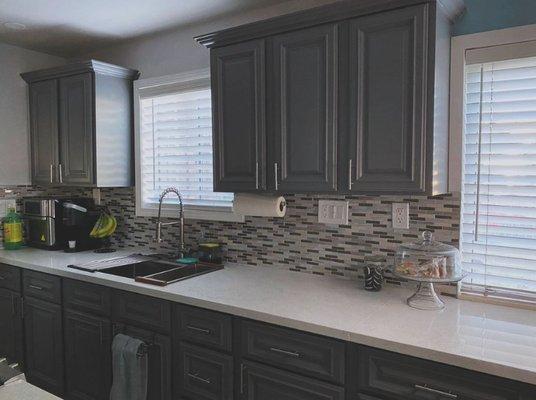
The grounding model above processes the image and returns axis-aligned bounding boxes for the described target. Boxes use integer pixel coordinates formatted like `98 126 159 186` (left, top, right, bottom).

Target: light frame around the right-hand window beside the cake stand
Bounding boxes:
448 24 536 309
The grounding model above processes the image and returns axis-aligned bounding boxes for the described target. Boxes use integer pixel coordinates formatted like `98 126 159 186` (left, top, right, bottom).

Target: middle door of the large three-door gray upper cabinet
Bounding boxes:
268 25 339 193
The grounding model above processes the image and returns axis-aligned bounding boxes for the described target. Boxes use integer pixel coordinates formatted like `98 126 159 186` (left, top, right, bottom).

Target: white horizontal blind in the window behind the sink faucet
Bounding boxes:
140 88 233 209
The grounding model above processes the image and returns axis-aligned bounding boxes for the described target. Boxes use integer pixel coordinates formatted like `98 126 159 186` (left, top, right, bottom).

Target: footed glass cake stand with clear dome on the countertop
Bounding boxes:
393 231 466 310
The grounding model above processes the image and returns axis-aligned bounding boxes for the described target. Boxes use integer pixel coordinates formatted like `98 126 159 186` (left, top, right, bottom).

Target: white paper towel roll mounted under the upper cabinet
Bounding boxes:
233 193 287 217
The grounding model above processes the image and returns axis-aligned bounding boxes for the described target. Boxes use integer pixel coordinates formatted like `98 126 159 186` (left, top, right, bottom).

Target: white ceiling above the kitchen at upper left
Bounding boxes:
0 0 288 57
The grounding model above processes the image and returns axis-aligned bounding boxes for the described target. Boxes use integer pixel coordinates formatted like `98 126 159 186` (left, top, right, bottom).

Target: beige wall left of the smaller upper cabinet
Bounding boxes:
0 43 65 186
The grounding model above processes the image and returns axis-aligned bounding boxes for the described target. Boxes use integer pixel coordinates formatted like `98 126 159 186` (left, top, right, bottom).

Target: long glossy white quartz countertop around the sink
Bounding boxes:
0 249 536 385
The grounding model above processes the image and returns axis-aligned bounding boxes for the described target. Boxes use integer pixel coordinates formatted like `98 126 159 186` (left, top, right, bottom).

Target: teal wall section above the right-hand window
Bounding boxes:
454 0 536 35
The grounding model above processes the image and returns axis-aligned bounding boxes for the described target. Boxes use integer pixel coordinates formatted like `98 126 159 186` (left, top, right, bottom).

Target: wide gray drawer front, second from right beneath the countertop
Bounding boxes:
241 321 345 383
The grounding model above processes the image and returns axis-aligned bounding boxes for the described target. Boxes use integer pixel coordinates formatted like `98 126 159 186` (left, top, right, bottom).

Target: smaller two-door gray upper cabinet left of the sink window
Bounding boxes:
21 60 138 187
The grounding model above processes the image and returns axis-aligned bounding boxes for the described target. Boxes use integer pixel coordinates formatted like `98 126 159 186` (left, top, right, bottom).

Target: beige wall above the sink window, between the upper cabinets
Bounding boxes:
85 0 336 78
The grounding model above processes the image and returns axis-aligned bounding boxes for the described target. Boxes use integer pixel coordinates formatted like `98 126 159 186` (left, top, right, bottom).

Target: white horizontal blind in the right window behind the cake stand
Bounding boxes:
460 57 536 299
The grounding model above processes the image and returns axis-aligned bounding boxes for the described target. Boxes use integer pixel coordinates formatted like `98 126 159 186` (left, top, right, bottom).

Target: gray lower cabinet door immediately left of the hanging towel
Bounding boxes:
64 310 112 400
